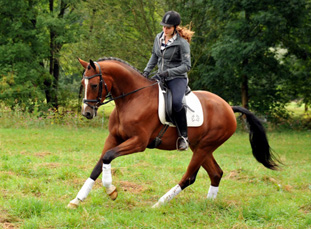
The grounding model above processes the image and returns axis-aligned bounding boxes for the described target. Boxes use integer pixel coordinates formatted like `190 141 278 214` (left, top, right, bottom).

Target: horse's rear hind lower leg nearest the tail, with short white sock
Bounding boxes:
202 153 223 199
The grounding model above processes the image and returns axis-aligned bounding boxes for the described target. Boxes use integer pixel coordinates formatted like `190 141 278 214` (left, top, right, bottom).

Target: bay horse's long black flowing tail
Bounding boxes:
232 106 279 170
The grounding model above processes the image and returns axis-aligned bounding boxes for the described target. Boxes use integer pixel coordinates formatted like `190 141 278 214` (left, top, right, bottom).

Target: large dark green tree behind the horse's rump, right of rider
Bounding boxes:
205 0 305 112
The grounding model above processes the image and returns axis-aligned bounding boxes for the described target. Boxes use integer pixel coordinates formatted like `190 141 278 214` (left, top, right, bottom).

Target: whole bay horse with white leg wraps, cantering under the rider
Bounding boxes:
68 58 278 208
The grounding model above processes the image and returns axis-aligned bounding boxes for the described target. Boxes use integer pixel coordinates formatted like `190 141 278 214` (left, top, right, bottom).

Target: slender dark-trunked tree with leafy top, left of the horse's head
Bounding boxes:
40 0 81 109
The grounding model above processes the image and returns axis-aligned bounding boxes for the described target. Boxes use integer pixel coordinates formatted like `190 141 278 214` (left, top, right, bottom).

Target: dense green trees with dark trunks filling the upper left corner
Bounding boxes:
0 0 80 109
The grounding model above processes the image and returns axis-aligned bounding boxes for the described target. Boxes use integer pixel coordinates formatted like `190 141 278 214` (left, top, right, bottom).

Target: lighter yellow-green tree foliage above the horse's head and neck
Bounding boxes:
60 0 163 106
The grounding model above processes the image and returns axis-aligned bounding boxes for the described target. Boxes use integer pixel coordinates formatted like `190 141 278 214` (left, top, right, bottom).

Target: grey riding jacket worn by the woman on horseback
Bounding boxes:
144 32 191 80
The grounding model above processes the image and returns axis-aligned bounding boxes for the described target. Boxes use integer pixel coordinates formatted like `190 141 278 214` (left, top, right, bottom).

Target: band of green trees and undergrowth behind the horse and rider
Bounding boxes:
0 0 311 128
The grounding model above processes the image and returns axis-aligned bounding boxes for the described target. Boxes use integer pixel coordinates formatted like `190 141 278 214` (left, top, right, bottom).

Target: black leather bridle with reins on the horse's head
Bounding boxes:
83 62 158 111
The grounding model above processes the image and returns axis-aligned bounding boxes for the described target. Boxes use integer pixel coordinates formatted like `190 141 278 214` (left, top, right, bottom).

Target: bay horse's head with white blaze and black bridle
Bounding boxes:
79 59 109 119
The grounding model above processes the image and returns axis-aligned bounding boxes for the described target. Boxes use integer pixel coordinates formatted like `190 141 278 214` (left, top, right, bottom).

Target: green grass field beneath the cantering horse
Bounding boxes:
0 125 311 228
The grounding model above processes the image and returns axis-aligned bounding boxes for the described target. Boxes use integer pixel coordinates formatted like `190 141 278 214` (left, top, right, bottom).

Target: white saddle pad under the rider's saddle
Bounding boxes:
158 86 204 127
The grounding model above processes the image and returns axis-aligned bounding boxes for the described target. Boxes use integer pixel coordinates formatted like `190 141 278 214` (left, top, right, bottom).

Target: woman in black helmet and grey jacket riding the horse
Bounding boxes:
143 11 194 150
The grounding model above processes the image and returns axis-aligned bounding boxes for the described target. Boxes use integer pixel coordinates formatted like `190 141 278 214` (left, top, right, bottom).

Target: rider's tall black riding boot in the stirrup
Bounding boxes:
174 107 189 150
